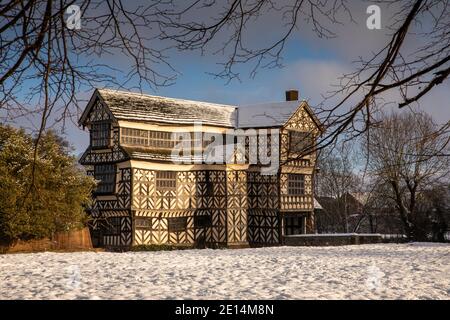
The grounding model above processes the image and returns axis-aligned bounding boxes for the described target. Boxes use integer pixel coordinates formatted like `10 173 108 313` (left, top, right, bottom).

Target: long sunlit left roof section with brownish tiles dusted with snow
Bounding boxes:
80 89 236 127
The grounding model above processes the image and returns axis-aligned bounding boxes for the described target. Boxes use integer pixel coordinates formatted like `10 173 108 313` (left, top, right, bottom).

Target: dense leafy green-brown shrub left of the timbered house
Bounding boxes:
0 125 95 243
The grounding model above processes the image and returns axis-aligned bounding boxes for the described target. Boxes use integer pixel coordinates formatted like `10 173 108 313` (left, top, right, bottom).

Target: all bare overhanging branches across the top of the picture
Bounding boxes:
0 0 450 153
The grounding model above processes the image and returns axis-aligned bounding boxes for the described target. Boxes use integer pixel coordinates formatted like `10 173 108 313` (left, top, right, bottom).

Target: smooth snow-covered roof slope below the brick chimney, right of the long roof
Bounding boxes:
238 101 301 128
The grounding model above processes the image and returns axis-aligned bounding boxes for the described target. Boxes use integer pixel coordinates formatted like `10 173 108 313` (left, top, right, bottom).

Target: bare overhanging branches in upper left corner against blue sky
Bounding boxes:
0 0 178 132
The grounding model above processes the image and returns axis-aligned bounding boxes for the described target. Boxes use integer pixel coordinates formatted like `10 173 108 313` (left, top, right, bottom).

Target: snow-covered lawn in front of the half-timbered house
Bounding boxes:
0 243 450 299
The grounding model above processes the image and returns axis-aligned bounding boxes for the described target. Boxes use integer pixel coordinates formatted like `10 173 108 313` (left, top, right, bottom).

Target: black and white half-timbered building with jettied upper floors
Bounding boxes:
79 89 322 250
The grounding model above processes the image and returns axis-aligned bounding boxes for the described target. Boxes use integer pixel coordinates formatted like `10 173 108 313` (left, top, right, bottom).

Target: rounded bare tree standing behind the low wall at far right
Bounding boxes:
365 112 450 240
